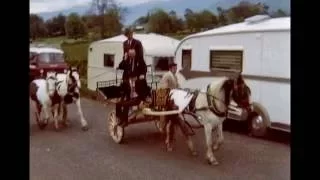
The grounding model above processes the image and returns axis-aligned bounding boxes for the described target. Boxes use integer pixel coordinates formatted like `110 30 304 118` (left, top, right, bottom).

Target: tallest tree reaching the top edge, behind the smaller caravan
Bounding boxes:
90 0 127 38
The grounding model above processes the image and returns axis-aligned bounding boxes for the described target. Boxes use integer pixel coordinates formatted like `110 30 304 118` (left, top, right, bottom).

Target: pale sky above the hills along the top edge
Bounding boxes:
29 0 165 13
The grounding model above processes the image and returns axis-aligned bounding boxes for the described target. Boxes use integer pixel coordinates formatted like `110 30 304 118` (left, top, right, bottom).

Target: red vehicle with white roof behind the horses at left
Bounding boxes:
29 47 68 81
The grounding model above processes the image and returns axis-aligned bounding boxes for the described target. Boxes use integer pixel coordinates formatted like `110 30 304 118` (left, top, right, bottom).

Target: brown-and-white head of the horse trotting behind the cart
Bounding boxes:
67 66 81 92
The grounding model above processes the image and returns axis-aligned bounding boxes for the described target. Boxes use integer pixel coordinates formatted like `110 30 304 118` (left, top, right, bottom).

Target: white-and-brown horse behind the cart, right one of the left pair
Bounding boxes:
56 67 88 131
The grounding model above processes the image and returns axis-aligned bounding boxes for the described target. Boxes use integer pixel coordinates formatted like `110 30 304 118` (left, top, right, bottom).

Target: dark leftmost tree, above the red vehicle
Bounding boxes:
29 14 47 39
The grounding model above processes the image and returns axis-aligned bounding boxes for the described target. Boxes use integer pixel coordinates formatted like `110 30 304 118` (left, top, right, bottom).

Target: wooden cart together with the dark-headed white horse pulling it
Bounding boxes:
97 64 255 165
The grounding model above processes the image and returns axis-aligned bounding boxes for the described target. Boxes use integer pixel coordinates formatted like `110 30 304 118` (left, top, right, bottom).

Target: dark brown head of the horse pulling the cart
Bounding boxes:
222 74 251 109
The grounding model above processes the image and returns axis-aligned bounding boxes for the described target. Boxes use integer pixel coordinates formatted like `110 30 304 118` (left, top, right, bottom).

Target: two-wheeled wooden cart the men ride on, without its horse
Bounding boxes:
97 66 198 143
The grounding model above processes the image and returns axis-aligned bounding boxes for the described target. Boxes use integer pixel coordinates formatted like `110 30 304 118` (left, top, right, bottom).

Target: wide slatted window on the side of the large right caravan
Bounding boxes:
210 50 243 72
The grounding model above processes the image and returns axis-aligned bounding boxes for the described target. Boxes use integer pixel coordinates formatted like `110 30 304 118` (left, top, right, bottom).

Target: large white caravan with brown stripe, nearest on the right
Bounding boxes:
175 15 290 136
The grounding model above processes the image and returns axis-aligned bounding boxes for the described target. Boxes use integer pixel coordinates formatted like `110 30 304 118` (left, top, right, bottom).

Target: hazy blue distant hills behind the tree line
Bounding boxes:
39 0 290 24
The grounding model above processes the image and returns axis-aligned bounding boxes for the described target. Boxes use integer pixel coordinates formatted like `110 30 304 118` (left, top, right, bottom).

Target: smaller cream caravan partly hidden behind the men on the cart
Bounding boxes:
87 33 180 90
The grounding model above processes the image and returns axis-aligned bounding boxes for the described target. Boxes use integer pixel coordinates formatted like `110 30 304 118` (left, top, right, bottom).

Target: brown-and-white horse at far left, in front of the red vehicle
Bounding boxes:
30 72 60 129
